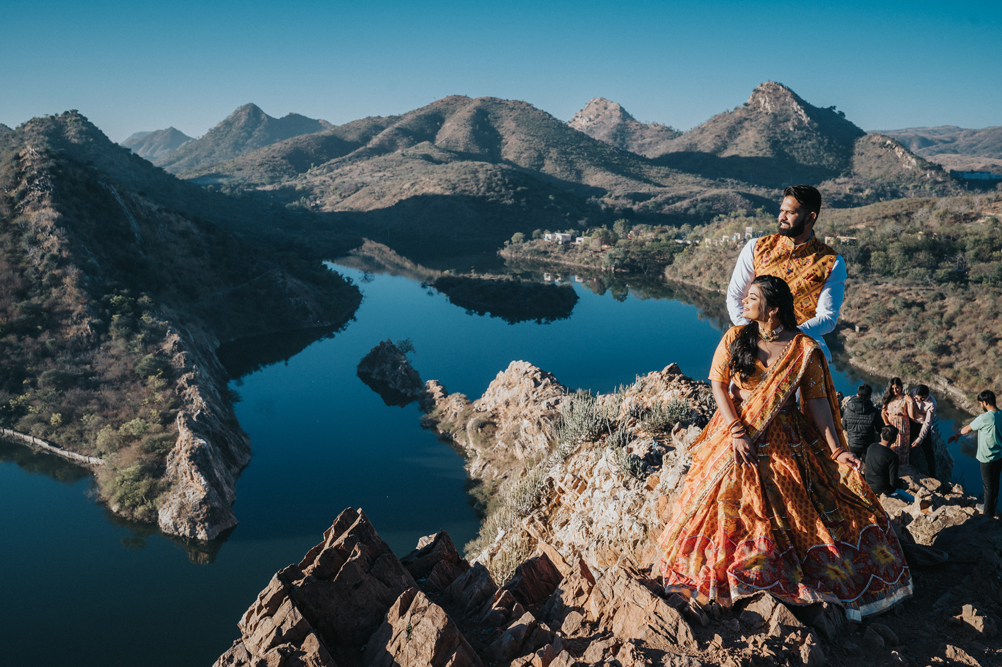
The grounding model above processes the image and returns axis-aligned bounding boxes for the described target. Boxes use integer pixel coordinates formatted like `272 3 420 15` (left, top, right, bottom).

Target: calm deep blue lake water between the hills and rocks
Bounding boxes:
0 262 980 666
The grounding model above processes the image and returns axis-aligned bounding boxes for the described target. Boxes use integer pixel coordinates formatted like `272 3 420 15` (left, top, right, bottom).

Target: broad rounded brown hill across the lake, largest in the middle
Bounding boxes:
180 96 771 246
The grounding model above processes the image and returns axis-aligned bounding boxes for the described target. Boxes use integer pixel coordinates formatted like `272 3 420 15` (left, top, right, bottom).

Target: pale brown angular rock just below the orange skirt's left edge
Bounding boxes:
587 566 694 648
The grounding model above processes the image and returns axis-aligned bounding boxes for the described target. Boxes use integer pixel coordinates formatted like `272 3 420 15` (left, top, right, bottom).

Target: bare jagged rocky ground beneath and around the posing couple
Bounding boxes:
216 350 1002 667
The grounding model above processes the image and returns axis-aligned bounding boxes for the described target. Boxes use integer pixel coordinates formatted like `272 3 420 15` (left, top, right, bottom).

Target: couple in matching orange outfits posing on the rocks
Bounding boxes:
659 185 913 620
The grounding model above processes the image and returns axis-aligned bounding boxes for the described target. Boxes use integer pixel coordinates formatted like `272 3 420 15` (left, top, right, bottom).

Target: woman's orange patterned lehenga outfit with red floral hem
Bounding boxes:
660 326 912 620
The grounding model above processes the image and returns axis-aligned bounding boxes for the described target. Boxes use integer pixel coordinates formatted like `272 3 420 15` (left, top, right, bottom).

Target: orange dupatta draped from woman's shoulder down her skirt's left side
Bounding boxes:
658 334 847 569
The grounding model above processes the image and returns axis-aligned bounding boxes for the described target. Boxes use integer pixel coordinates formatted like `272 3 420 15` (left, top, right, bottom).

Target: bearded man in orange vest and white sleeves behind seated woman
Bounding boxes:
727 185 846 362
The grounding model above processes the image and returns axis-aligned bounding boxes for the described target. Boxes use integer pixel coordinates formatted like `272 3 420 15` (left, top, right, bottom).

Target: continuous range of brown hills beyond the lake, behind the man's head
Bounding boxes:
160 82 957 247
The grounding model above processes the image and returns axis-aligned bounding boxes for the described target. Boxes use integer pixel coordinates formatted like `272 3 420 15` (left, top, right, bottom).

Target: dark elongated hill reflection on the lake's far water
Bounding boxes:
432 275 577 324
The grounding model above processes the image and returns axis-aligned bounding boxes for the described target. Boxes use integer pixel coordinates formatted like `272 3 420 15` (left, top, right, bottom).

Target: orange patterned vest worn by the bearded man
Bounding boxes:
754 234 839 324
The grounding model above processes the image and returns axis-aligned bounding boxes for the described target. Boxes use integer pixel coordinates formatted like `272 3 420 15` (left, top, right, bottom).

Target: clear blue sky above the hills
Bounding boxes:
0 0 1002 141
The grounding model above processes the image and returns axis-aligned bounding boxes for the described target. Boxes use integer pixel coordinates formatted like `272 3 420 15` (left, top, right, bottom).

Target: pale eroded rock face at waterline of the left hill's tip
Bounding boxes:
157 331 251 540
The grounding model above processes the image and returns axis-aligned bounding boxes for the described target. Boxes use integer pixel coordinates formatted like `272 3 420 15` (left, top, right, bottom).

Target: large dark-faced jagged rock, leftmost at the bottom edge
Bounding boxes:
211 509 416 665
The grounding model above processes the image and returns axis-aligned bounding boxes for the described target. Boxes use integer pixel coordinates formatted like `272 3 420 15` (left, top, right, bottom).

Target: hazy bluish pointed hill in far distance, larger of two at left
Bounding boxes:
154 104 331 173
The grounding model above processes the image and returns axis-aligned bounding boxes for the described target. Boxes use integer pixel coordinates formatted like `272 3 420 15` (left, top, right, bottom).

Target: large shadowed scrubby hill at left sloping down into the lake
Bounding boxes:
0 111 361 540
